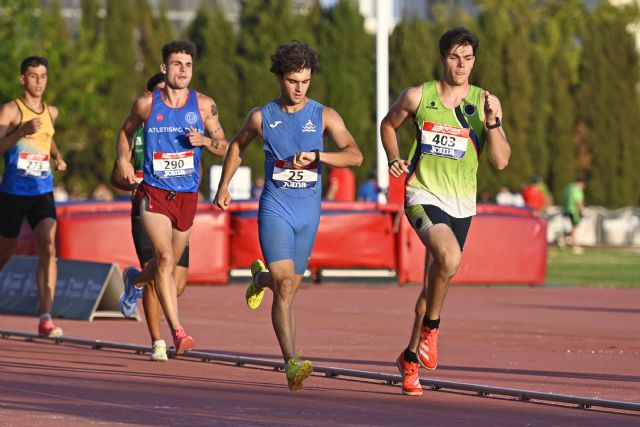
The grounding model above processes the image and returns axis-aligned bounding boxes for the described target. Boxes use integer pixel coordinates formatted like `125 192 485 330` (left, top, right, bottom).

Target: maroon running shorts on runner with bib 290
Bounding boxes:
131 181 198 231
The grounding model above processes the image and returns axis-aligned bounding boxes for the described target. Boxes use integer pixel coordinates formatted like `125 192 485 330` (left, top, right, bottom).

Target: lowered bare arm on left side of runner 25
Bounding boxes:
214 108 262 210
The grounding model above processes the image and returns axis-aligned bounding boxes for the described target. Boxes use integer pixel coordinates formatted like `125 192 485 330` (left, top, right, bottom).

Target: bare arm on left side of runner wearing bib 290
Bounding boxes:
114 95 151 185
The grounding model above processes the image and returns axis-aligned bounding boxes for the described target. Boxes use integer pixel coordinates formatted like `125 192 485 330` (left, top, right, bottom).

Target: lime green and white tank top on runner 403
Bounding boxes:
405 81 485 218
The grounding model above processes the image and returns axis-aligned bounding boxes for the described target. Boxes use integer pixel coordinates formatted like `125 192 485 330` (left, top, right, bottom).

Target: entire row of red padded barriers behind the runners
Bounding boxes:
12 201 547 284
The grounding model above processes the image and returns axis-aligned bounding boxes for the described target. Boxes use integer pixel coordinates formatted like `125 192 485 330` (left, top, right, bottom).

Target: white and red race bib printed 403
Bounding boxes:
420 122 470 160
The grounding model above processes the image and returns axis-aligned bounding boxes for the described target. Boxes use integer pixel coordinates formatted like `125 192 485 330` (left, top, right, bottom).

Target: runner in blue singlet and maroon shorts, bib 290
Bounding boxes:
116 41 227 354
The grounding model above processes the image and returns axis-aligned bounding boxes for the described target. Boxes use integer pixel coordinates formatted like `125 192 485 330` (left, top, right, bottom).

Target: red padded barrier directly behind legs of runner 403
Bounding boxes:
397 214 547 285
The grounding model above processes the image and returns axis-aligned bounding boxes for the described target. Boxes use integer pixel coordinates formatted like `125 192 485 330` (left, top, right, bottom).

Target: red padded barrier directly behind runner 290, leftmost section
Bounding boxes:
57 203 229 283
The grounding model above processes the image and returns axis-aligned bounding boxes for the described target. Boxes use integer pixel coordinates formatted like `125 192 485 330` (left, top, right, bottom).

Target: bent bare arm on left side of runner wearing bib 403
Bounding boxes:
380 85 422 177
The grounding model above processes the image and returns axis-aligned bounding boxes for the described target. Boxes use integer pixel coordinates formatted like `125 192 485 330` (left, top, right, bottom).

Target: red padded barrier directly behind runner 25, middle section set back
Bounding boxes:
230 208 395 269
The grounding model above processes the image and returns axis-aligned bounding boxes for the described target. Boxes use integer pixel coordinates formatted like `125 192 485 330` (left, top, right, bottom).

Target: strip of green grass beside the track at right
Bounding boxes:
545 246 640 289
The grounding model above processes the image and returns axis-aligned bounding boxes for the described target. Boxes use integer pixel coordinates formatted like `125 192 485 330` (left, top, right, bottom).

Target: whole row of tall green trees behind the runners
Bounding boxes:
0 0 640 207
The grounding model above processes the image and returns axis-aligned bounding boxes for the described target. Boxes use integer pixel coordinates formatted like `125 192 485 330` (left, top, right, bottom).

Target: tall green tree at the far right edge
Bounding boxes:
578 3 640 206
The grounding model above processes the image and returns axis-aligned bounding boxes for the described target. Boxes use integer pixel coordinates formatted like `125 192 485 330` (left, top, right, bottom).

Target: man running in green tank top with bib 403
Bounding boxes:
380 28 511 395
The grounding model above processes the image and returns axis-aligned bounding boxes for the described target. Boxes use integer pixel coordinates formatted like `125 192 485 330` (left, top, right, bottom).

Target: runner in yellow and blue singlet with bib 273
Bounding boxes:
0 56 67 338
